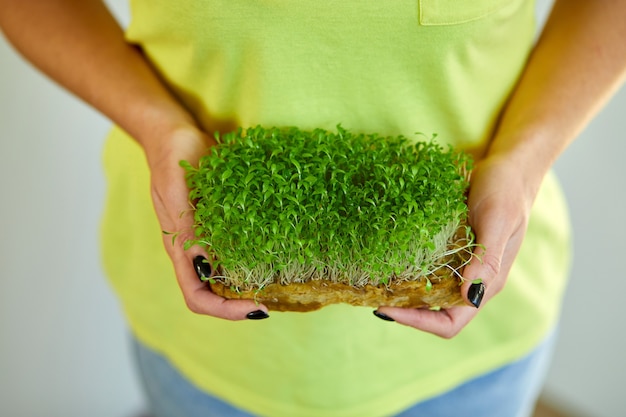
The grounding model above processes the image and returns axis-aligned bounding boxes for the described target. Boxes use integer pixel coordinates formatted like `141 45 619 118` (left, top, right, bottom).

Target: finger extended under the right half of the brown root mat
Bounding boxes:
377 307 477 339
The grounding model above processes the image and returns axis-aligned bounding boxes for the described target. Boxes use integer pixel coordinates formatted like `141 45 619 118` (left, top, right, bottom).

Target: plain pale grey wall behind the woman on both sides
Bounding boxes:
0 0 626 417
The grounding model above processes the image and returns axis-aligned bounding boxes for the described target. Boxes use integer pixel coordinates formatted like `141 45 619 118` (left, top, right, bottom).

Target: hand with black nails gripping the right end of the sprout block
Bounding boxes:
378 157 536 338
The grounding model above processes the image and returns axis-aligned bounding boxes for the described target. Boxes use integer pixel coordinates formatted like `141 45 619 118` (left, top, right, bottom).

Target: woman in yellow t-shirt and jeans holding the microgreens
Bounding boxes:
0 0 626 416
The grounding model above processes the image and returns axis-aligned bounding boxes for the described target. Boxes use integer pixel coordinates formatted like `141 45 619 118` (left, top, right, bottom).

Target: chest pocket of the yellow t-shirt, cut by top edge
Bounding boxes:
419 0 517 26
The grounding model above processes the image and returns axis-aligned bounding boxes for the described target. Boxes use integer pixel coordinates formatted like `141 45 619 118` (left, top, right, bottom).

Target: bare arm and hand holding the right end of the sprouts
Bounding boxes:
379 0 626 337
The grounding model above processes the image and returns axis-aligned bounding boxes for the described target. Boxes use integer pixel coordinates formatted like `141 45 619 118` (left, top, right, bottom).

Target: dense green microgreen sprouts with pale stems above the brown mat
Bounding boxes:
181 126 474 290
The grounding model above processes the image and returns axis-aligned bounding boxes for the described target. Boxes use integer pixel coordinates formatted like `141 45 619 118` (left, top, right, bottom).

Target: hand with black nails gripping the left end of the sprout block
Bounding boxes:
144 125 267 320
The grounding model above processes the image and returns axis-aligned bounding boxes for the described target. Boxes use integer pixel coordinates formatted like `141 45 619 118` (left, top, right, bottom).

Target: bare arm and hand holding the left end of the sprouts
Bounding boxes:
0 0 267 320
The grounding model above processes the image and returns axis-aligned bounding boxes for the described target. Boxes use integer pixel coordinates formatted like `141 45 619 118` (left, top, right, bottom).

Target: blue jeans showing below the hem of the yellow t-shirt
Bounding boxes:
133 332 556 417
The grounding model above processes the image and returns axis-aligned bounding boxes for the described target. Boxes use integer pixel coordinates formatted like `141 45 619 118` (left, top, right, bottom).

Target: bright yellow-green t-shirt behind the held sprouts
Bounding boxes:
102 0 570 417
